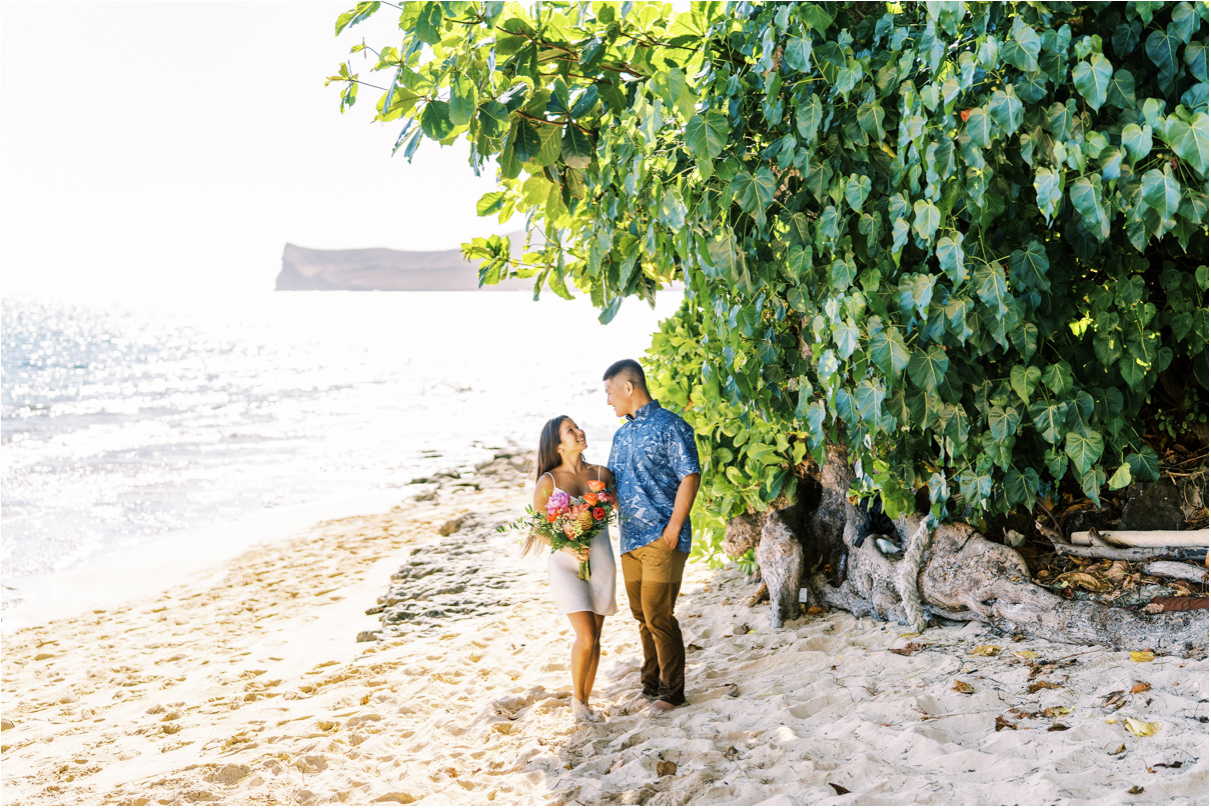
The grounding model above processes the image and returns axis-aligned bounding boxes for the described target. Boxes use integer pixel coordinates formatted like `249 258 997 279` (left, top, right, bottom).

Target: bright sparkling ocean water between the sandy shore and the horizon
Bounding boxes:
0 292 679 578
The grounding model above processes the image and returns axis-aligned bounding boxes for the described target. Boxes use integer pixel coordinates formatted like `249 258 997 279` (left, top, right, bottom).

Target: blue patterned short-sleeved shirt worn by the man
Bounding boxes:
609 401 700 552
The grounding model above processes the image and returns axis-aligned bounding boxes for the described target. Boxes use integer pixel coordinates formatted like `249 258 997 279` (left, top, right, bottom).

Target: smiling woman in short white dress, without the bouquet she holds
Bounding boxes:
522 416 618 721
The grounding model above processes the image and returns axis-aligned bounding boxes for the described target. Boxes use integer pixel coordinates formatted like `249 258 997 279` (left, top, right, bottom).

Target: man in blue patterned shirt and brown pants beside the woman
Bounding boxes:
602 359 701 715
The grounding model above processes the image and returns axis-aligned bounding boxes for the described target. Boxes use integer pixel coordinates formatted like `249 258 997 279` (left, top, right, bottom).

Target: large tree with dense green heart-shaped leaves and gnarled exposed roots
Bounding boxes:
333 1 1209 651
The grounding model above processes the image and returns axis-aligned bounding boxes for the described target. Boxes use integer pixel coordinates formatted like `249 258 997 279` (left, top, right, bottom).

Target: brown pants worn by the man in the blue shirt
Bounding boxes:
622 538 689 704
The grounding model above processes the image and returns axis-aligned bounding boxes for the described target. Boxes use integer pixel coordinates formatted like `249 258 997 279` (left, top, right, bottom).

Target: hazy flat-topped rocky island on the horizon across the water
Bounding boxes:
275 237 534 292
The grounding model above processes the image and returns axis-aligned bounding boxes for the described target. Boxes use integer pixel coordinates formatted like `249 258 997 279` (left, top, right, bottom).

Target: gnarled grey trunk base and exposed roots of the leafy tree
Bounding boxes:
737 447 1207 658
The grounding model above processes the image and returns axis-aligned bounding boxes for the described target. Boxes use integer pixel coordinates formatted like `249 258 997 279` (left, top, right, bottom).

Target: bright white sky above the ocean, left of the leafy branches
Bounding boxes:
0 0 520 296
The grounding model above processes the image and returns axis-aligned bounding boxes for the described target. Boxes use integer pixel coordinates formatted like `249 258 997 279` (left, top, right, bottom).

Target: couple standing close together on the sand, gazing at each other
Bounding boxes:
526 359 701 721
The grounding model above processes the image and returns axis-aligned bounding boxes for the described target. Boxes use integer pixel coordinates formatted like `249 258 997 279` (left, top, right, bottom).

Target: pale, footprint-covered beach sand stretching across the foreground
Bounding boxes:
2 477 1207 804
